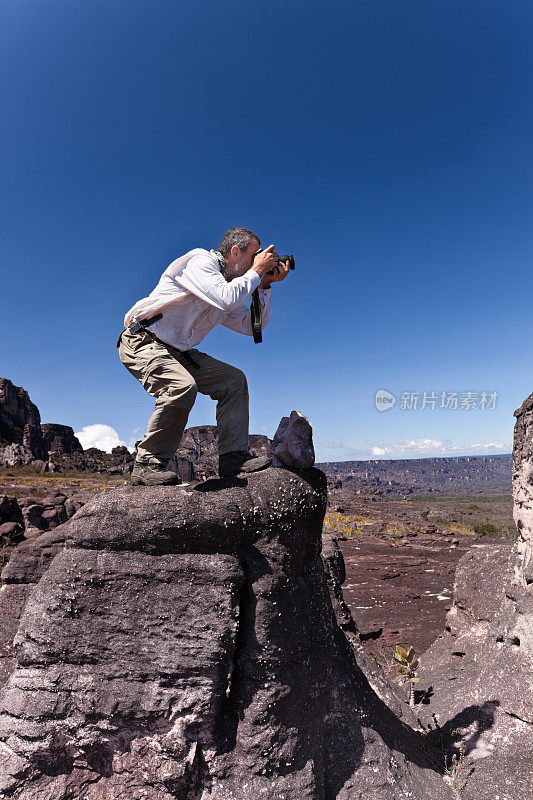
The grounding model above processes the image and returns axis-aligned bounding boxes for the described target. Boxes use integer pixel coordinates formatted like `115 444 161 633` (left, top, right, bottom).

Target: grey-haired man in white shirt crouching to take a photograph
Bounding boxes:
118 228 290 486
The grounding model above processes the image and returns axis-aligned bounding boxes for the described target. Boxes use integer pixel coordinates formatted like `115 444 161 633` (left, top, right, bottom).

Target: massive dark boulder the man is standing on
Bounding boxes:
0 468 451 800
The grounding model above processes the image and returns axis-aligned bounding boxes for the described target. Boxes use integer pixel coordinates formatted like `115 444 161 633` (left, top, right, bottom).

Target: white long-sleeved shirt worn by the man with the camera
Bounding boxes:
124 248 272 350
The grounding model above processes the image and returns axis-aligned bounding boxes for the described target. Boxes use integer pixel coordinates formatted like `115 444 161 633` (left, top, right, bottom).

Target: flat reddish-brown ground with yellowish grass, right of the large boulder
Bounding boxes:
324 488 517 671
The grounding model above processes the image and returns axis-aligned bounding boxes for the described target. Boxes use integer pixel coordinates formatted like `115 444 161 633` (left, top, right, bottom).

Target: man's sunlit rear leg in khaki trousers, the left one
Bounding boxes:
119 331 197 465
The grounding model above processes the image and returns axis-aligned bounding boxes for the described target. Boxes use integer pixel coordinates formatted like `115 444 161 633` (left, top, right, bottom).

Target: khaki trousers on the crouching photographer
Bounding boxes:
118 330 248 463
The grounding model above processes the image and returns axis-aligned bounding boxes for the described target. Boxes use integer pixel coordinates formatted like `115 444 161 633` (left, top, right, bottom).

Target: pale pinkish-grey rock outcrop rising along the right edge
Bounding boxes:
419 394 533 800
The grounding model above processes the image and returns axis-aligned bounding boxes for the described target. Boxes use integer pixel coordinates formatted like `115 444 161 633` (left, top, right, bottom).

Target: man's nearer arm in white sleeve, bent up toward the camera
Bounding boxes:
175 255 261 312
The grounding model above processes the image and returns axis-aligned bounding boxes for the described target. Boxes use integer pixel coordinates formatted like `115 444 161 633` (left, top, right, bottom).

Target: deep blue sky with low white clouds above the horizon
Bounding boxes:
0 0 533 460
